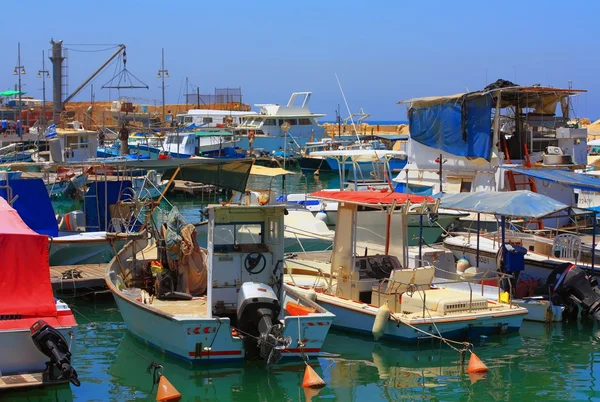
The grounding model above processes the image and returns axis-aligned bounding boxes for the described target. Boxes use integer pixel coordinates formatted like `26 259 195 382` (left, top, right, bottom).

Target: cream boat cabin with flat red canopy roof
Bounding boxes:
319 191 437 302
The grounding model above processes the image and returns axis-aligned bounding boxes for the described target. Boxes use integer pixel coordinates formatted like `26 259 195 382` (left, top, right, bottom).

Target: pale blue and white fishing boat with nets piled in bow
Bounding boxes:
106 206 334 365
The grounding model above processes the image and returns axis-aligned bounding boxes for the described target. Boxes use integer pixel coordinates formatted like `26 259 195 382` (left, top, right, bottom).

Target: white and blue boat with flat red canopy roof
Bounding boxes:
286 192 527 342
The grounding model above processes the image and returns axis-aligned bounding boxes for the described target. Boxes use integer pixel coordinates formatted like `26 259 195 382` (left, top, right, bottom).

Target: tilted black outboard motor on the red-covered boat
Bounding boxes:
29 320 80 387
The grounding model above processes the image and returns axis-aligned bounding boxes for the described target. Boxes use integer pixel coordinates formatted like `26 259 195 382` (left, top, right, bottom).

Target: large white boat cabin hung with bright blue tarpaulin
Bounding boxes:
394 80 587 204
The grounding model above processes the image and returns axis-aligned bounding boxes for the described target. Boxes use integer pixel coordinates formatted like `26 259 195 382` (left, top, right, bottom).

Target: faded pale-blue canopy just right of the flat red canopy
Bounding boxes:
440 190 570 219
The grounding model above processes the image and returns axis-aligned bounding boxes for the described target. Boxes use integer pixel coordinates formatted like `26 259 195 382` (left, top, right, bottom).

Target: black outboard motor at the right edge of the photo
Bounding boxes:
546 263 600 321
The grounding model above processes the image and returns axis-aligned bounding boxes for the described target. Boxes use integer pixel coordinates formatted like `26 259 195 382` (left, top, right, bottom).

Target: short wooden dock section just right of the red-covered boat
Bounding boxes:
50 264 107 291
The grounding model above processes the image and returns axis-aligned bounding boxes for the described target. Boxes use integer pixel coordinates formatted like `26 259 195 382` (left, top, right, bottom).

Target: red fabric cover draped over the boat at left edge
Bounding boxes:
0 197 57 317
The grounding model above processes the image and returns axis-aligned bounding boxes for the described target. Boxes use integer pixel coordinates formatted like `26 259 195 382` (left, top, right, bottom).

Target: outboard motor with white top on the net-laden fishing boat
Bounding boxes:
237 282 292 366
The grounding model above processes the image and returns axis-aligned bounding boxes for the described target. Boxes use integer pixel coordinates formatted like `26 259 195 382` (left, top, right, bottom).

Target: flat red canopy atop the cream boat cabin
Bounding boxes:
310 190 434 205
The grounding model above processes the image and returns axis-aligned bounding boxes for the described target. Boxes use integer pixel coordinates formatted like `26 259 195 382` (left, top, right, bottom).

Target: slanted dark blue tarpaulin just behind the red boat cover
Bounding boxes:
0 179 58 237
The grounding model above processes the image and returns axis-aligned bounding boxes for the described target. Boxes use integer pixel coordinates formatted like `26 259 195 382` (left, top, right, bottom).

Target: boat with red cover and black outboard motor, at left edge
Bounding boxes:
0 197 77 383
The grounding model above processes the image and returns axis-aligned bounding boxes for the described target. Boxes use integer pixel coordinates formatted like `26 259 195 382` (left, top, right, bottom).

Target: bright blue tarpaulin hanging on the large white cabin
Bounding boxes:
408 95 492 161
